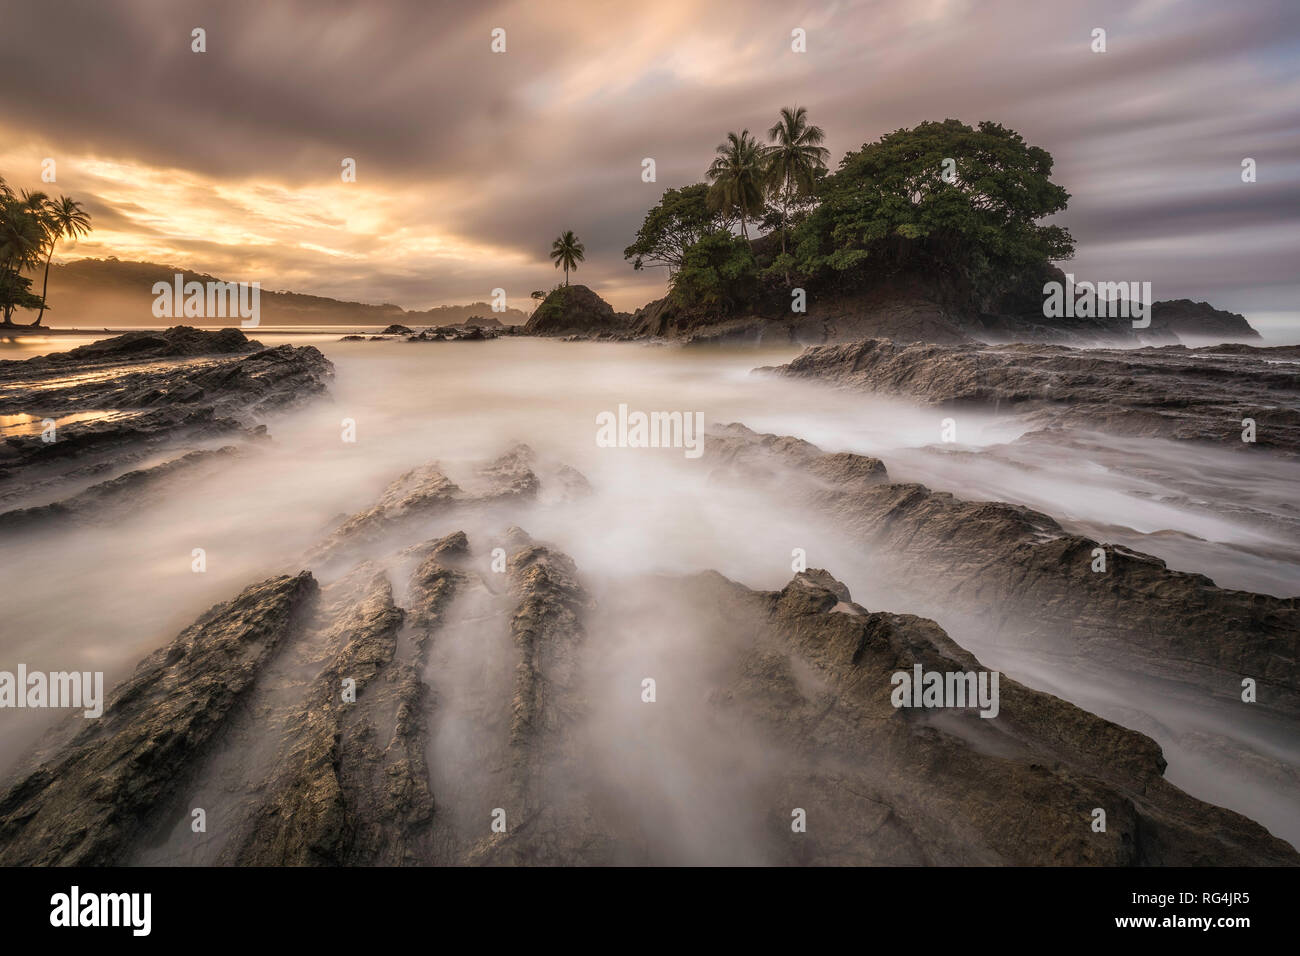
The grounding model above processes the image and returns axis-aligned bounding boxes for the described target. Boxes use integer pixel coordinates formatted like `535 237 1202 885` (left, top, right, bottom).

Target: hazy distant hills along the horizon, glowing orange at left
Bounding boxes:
38 258 528 328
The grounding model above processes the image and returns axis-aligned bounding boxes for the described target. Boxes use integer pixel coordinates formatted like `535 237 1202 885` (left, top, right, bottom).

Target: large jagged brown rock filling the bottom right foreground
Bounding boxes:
689 571 1300 865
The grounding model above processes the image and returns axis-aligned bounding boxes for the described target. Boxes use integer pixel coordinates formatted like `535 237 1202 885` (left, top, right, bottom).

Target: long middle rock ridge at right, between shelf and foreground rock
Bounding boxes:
706 424 1300 719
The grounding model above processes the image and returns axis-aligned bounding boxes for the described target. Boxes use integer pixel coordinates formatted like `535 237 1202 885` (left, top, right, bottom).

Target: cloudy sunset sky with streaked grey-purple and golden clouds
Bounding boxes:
0 0 1300 316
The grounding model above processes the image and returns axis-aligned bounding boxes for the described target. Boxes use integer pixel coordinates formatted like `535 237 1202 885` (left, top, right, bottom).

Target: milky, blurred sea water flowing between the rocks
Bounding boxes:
0 332 1300 845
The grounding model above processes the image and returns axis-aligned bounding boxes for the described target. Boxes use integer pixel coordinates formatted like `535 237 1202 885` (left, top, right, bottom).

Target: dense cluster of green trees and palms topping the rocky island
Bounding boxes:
624 114 1074 311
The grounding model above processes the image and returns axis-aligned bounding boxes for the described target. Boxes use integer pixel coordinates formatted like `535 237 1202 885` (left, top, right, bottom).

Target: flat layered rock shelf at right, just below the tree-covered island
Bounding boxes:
759 339 1300 454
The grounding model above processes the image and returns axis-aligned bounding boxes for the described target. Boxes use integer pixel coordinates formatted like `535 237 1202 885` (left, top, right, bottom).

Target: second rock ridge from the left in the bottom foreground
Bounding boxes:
218 566 441 866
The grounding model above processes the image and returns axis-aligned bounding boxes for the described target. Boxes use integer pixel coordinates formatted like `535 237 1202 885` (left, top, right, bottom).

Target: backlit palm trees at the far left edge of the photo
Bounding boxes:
0 177 90 328
